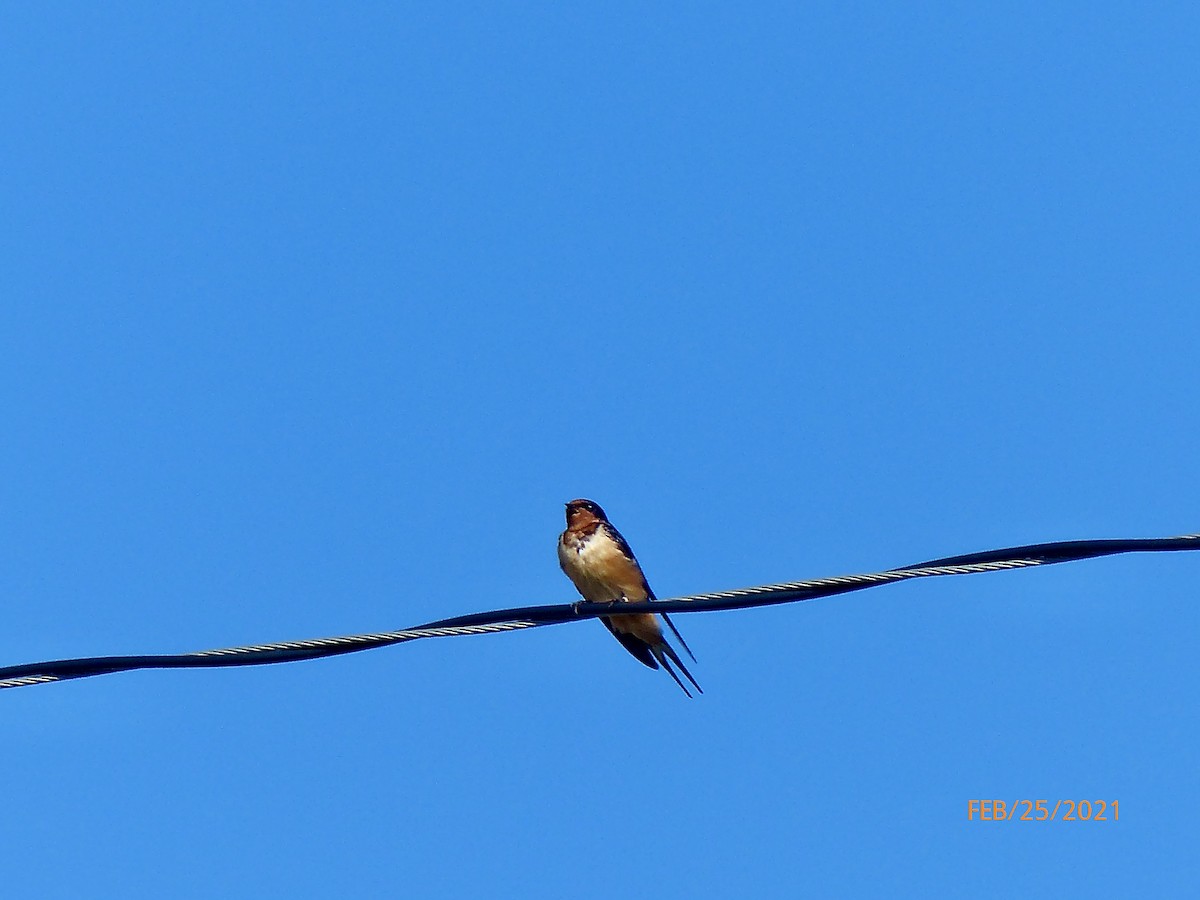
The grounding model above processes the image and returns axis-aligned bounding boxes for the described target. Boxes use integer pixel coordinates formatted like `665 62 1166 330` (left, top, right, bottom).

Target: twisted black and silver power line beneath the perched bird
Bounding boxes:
0 534 1200 689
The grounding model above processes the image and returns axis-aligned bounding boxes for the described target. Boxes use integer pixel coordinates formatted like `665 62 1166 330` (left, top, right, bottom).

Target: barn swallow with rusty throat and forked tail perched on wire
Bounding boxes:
558 499 704 697
